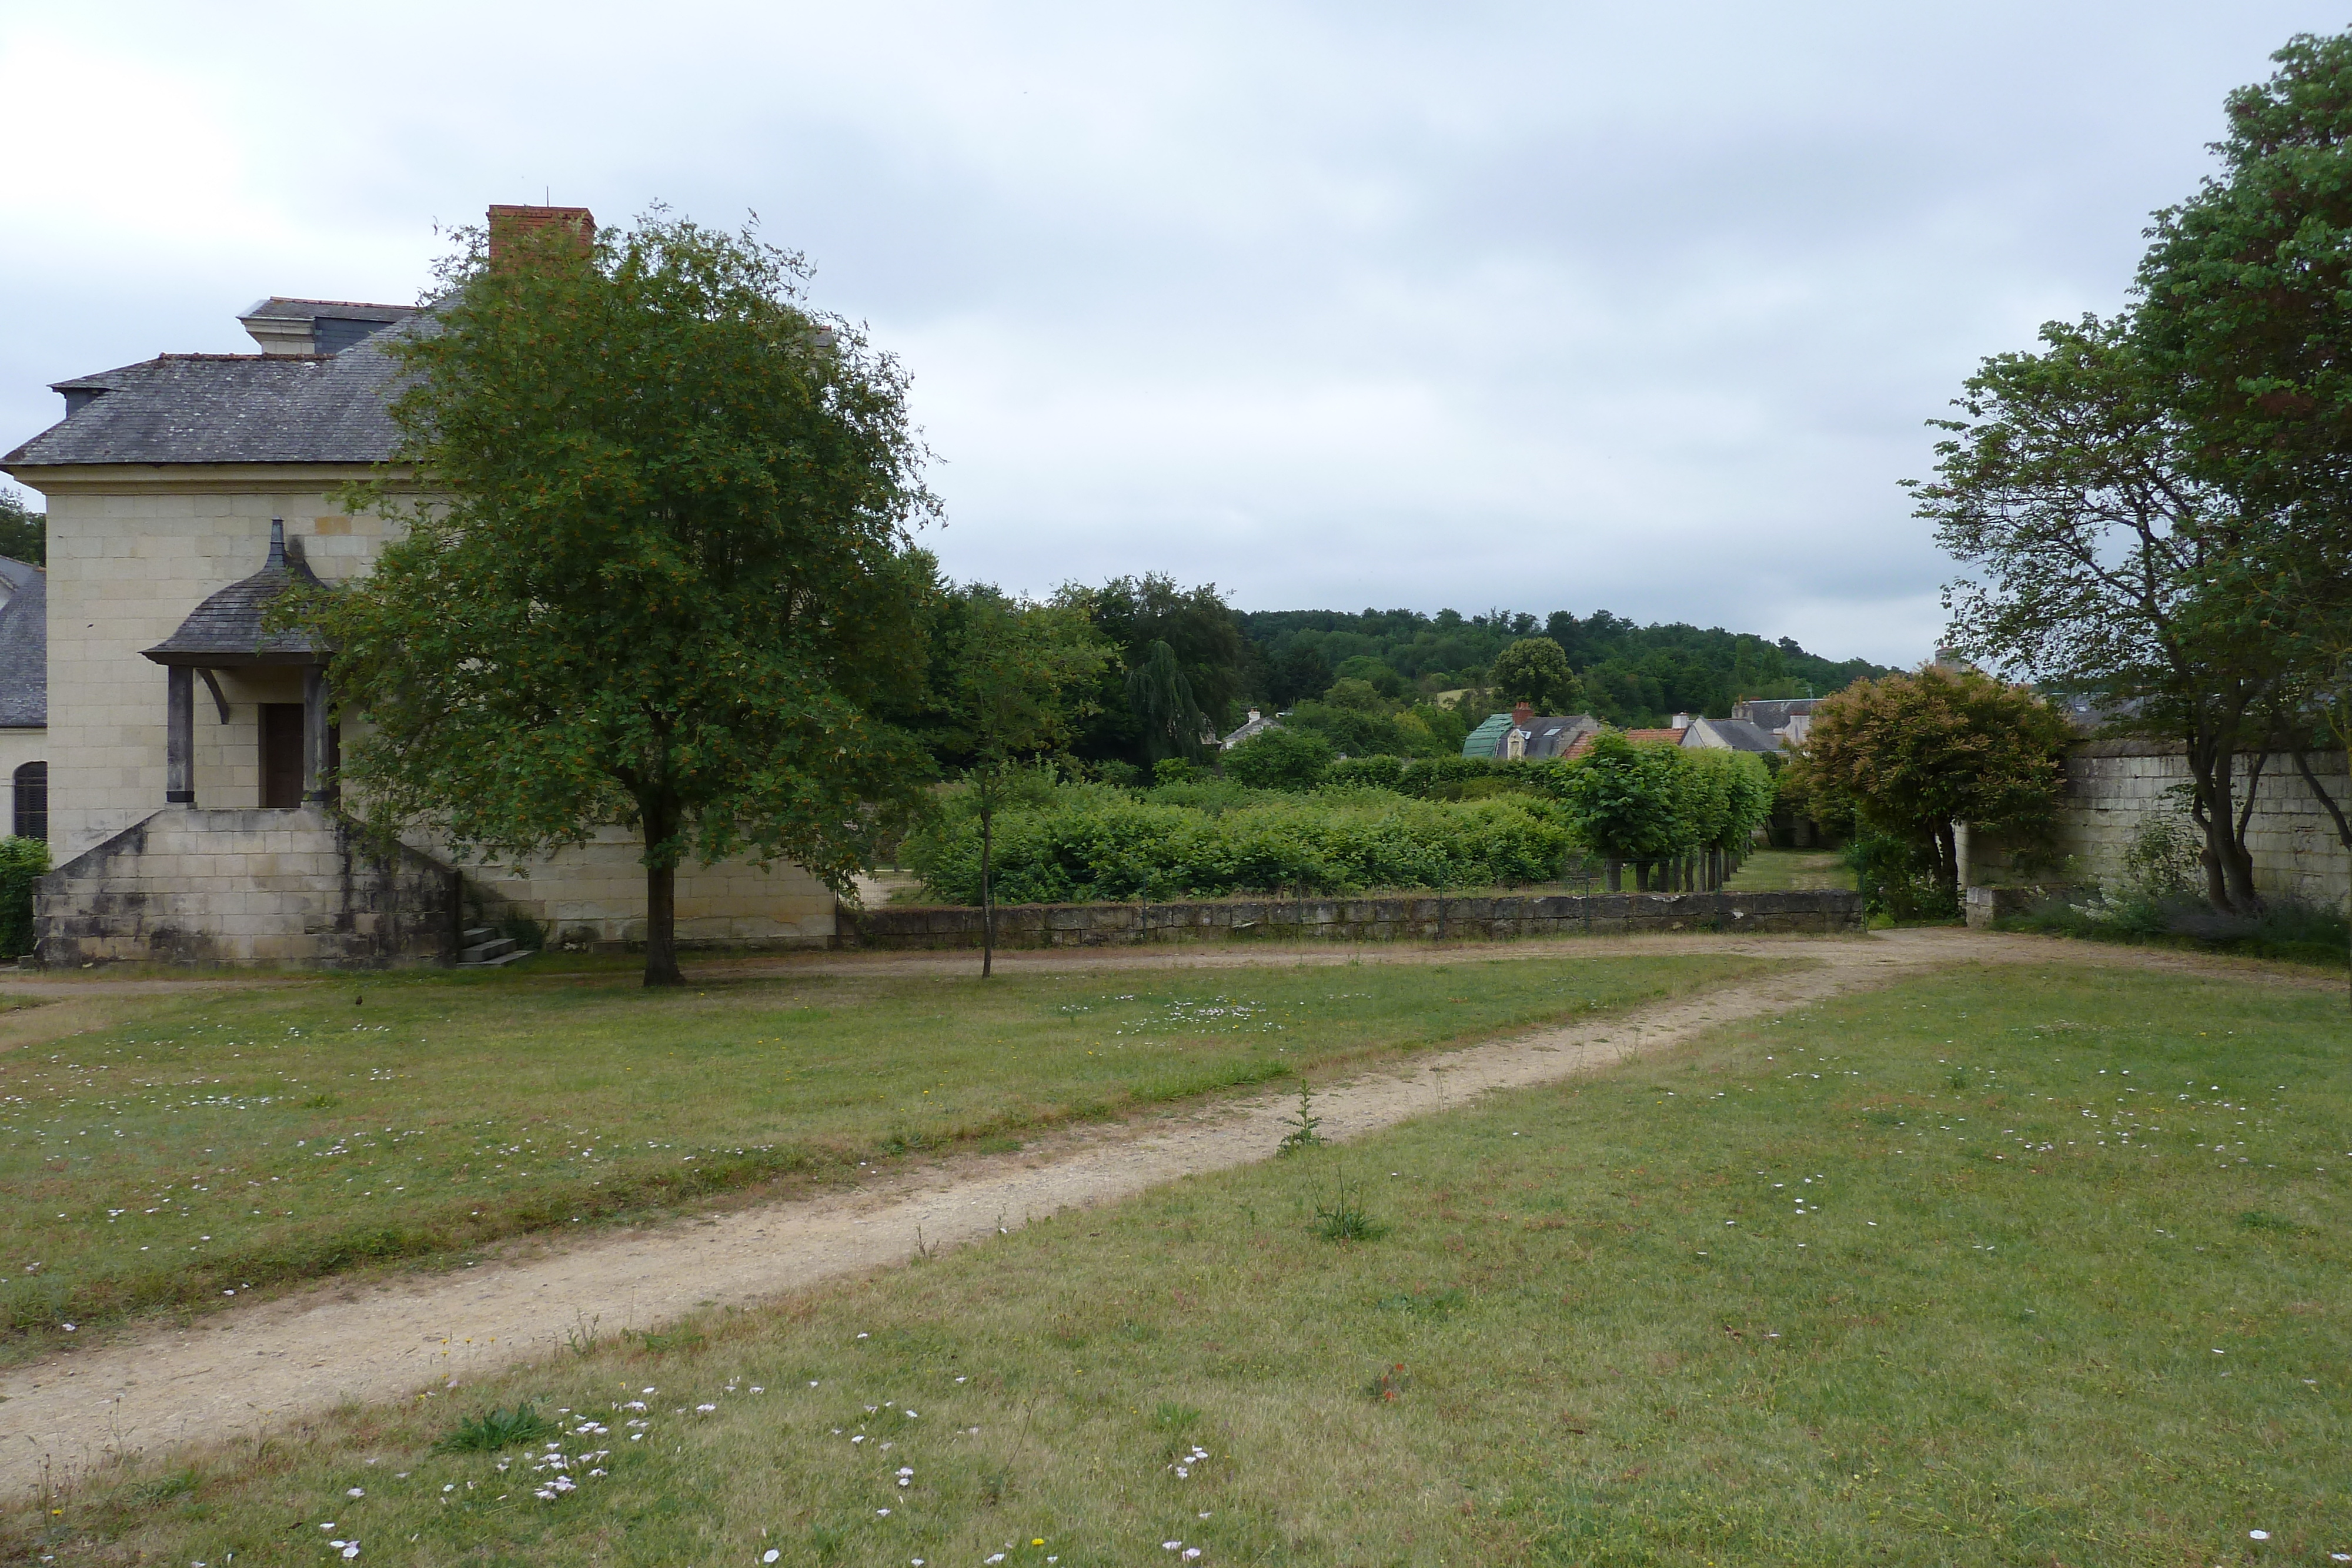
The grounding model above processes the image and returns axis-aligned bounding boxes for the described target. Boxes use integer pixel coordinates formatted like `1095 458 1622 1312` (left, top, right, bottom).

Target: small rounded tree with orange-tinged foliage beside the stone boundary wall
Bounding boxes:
1795 666 2072 898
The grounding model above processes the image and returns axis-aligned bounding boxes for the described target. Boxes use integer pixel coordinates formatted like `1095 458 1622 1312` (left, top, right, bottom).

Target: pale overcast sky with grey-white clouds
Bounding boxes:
0 0 2345 663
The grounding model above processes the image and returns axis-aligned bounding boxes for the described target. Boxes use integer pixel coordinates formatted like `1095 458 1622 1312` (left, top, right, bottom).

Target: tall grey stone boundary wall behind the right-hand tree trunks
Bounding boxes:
2056 741 2352 910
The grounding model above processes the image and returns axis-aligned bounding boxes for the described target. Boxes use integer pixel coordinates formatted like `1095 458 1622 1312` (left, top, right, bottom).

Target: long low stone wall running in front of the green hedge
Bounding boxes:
840 891 1863 947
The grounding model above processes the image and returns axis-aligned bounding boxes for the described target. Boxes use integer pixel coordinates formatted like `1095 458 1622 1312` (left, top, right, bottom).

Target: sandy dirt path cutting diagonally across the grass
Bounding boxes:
0 931 2333 1495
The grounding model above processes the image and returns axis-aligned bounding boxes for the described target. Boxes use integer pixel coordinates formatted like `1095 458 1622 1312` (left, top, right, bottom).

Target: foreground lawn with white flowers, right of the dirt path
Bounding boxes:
23 966 2352 1568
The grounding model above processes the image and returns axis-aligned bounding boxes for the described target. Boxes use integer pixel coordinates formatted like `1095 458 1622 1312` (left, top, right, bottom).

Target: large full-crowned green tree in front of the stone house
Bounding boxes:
320 214 934 985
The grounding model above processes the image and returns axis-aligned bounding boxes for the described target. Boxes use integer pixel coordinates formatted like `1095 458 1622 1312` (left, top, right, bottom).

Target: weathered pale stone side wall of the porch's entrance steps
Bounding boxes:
33 806 459 968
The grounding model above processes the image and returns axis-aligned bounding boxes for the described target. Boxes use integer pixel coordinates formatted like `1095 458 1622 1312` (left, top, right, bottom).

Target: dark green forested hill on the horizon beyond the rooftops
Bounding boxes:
1235 609 1886 727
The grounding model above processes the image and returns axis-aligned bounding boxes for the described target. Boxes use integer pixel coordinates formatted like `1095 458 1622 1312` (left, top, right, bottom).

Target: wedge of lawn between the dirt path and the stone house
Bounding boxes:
0 957 1759 1356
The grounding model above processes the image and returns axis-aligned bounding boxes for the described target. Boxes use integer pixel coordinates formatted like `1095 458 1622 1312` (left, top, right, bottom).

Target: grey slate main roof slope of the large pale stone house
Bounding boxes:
0 339 414 468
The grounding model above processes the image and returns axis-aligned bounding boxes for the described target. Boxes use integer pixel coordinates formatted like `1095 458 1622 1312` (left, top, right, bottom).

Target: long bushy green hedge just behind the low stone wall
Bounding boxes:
908 790 1571 905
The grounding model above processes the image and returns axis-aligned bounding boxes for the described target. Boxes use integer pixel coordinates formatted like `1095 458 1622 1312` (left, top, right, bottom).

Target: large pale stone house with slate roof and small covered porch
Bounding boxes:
0 209 835 964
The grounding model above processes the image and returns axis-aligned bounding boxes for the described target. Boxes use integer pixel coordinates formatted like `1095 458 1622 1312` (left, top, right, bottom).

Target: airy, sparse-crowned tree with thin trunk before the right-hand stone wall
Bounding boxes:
1919 317 2286 910
